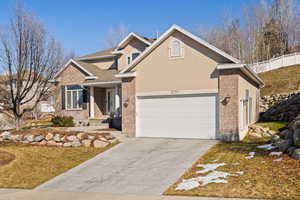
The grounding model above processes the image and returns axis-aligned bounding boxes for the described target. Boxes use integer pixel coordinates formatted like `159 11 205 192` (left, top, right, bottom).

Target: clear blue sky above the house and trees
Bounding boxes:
0 0 258 56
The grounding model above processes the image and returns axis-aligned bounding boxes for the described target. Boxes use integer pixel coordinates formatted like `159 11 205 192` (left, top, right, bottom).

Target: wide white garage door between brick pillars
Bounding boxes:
136 94 216 139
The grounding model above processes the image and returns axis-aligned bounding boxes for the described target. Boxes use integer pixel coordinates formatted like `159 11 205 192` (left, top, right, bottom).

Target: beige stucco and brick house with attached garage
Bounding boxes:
55 25 264 140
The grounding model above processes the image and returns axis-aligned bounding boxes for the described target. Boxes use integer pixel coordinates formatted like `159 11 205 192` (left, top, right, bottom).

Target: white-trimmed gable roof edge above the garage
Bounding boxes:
120 25 241 73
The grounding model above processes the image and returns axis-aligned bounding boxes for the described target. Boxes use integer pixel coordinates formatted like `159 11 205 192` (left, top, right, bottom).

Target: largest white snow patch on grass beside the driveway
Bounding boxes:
175 163 244 190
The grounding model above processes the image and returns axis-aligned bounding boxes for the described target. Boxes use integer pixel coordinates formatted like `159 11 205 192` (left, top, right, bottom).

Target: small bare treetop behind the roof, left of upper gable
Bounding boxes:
104 24 128 48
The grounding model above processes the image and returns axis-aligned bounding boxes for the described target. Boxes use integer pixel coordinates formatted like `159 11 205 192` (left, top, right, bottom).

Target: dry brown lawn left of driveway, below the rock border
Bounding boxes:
0 141 117 189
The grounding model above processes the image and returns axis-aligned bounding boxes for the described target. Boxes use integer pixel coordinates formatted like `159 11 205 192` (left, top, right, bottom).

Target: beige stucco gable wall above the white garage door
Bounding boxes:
135 32 226 94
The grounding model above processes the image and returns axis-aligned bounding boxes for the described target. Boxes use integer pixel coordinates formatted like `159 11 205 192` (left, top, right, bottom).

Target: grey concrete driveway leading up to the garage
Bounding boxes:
36 138 217 195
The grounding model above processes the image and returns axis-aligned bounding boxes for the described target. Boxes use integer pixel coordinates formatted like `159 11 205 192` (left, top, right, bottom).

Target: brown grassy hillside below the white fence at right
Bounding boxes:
259 65 300 96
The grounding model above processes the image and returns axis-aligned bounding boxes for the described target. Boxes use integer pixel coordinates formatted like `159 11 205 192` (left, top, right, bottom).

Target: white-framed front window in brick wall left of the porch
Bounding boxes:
66 85 83 109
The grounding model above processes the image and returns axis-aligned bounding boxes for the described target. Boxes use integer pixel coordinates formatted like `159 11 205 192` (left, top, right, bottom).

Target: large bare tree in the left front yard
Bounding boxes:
0 6 63 129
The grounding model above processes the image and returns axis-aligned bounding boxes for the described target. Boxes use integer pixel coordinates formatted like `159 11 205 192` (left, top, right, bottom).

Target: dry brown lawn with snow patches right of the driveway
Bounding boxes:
165 142 300 200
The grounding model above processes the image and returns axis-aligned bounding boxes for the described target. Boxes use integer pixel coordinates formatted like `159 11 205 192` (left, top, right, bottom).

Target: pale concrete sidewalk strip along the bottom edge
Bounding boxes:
0 190 262 200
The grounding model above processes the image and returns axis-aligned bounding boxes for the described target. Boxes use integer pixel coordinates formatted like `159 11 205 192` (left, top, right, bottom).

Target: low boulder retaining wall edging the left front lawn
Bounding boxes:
0 131 118 148
